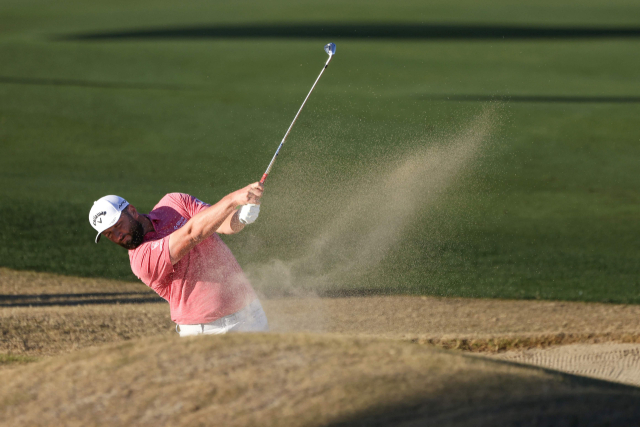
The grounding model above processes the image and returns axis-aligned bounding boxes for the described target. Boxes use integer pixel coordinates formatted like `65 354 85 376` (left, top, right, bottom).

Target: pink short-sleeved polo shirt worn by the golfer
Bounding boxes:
129 193 256 325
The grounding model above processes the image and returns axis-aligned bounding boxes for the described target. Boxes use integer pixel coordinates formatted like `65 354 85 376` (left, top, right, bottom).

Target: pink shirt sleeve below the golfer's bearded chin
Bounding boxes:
131 235 174 299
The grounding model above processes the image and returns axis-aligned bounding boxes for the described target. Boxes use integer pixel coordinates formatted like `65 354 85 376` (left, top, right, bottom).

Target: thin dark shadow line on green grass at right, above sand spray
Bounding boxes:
419 95 640 104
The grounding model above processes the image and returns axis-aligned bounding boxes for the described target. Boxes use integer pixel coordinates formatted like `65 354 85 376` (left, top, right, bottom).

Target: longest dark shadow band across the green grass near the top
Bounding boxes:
56 23 640 41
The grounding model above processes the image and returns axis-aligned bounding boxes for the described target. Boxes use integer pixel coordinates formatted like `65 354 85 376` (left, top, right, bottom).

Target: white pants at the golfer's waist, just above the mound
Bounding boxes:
176 298 269 337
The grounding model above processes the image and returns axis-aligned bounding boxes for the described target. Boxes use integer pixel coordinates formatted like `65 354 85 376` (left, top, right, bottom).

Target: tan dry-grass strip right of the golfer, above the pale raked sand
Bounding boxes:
264 296 640 351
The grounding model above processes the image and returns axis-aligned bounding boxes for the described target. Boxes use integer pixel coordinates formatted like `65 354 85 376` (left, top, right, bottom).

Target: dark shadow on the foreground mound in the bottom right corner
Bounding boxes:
328 364 640 427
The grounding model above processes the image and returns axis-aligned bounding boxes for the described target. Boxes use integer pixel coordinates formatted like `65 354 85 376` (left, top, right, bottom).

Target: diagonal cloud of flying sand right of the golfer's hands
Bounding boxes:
232 107 497 308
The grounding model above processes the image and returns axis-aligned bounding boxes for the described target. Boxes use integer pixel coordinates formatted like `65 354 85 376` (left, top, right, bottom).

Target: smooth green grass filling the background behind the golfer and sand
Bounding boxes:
0 0 640 303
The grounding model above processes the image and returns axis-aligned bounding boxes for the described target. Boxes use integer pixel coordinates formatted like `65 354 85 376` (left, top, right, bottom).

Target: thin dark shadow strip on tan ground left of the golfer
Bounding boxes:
0 292 165 308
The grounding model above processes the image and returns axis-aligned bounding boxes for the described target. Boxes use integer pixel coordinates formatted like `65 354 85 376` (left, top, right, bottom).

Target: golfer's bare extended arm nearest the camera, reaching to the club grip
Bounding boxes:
169 182 264 265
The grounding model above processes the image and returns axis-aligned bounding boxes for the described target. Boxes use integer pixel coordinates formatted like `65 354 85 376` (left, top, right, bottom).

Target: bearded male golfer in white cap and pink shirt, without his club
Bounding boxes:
89 183 269 337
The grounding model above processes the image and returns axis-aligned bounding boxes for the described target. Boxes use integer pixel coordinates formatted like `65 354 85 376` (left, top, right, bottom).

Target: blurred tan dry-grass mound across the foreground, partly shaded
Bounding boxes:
0 334 640 427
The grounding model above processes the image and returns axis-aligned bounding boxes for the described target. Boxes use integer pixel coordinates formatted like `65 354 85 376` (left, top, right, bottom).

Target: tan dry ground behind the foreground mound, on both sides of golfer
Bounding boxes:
0 269 640 385
